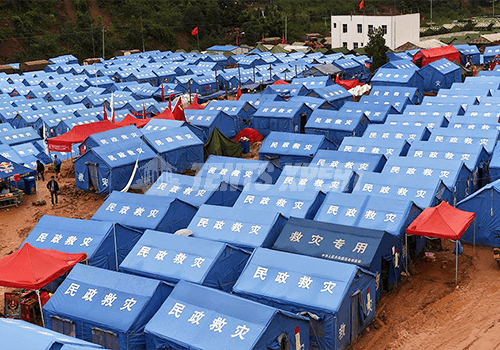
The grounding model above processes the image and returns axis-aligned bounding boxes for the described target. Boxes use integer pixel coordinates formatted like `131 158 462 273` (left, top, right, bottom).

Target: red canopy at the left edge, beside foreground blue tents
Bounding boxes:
0 243 87 290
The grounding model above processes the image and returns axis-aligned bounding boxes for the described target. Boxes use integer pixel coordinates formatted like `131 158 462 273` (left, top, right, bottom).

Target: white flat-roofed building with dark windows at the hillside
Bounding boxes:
332 13 420 50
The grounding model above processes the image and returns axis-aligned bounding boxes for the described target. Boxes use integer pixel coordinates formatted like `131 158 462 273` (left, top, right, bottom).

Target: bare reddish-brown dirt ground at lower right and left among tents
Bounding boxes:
0 160 500 350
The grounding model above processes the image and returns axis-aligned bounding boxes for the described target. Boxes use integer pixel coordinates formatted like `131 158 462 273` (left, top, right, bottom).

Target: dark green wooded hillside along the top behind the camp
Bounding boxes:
0 0 494 62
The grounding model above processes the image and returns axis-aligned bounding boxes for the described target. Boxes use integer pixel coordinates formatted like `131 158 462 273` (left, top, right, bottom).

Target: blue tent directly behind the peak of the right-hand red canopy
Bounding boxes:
382 157 477 205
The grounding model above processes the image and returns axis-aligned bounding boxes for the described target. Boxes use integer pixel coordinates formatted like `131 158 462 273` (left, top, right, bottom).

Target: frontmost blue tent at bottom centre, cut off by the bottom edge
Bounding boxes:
145 282 310 350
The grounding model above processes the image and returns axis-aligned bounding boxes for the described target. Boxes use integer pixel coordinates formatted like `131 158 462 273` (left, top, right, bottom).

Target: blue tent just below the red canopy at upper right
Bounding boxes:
418 58 462 92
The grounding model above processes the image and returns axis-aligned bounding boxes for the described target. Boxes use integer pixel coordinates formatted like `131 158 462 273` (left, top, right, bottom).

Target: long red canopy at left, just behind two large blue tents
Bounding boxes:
47 120 119 152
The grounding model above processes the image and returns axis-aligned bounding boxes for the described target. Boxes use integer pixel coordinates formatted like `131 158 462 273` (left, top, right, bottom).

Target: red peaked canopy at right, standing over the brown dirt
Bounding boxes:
406 201 476 240
